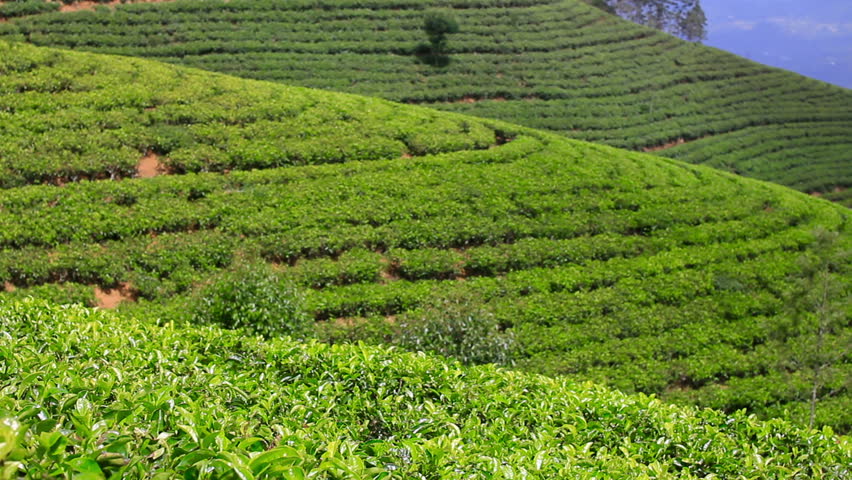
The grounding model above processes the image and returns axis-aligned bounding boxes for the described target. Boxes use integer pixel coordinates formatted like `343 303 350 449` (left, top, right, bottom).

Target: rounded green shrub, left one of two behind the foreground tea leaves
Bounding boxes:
192 263 313 339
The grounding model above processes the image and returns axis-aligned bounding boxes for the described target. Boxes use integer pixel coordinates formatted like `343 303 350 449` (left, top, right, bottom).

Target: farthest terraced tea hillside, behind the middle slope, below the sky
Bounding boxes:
0 0 852 206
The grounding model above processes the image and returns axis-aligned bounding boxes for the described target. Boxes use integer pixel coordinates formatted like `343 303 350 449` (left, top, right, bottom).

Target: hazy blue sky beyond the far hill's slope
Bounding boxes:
701 0 852 88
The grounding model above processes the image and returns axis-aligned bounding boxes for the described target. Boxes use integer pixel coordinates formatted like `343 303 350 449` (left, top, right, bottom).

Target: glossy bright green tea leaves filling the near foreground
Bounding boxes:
0 300 852 479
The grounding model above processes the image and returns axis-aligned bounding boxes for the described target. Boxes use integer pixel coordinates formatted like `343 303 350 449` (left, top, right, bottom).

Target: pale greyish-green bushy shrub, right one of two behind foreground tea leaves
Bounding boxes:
394 296 517 365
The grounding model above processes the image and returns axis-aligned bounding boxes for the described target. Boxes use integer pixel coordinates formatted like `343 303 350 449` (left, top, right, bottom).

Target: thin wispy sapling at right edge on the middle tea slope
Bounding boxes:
775 229 852 427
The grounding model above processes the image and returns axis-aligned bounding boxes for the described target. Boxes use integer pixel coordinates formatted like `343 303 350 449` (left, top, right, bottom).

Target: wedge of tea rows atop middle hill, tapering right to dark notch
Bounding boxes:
0 42 497 188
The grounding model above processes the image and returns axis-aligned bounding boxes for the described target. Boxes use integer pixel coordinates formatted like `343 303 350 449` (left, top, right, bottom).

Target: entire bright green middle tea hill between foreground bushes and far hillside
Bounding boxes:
0 42 852 442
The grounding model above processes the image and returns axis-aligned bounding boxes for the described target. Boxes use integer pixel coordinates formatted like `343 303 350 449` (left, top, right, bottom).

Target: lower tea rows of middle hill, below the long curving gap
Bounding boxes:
0 124 852 431
